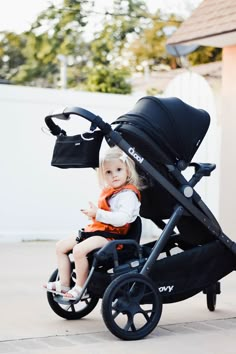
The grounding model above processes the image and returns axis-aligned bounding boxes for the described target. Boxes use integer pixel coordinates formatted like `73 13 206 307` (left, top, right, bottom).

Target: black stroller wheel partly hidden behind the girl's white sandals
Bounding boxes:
47 269 99 320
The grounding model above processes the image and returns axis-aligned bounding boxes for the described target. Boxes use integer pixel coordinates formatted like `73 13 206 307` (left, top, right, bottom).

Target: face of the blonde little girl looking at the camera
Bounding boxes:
104 159 128 189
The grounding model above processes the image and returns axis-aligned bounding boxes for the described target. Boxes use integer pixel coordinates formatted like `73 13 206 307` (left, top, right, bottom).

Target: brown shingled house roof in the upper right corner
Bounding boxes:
167 0 236 47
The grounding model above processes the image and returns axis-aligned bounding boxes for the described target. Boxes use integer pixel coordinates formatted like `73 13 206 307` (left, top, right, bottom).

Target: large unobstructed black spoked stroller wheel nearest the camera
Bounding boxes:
102 274 162 340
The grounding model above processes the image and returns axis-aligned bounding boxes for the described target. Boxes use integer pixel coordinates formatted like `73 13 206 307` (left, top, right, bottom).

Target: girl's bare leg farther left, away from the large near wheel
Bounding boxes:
56 236 77 287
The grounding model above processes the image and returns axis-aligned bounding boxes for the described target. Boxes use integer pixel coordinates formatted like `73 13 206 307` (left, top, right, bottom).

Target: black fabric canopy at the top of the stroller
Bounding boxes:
113 96 210 163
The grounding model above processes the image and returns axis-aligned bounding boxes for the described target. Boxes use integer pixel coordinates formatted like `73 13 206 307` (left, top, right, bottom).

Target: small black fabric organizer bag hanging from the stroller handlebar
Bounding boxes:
51 130 103 168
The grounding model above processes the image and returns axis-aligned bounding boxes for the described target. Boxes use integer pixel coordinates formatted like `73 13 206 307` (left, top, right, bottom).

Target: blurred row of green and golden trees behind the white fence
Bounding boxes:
0 0 221 93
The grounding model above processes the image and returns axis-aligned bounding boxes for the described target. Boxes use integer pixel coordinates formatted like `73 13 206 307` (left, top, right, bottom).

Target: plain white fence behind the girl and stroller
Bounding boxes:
0 85 218 241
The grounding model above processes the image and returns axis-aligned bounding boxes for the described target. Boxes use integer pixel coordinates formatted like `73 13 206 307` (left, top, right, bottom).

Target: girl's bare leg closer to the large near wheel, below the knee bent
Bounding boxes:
73 236 109 287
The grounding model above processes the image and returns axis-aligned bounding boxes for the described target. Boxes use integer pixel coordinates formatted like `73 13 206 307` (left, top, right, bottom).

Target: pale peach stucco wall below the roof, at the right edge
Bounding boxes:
220 46 236 240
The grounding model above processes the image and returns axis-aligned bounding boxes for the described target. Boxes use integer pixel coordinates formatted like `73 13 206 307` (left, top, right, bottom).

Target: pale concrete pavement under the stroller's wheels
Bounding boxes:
0 241 236 354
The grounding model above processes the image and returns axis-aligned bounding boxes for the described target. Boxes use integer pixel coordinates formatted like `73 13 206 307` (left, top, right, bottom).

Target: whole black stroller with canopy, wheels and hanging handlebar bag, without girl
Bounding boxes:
45 96 236 340
